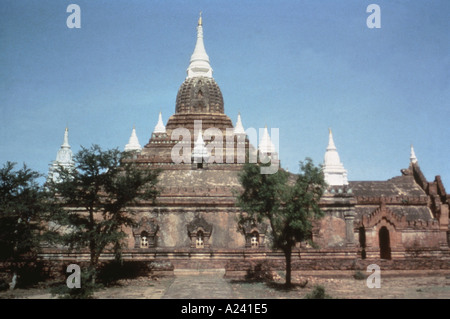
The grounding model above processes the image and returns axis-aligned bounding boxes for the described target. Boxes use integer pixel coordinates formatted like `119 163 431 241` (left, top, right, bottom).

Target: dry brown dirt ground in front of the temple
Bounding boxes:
0 271 450 299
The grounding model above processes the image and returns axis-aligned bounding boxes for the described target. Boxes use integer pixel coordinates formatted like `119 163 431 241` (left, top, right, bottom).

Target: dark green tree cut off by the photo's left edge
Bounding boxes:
0 162 51 289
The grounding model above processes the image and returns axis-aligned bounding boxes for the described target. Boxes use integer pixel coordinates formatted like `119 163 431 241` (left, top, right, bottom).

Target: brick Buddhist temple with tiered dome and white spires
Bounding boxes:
43 16 450 275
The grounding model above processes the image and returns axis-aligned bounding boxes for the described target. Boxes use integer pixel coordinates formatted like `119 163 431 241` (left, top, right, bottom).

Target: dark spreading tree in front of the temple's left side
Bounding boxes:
47 145 159 284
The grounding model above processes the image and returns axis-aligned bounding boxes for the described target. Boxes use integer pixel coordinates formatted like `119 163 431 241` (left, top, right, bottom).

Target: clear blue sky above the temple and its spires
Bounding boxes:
0 0 450 191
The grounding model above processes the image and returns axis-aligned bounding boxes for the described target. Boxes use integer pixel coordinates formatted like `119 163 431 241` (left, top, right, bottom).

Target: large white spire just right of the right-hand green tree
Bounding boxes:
323 129 348 186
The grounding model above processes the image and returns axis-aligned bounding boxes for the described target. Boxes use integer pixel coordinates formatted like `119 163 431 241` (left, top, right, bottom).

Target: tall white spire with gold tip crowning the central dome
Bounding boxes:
187 12 213 78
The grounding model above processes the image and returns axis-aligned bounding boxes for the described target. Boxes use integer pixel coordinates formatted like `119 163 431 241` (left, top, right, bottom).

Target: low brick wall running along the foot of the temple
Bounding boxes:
31 248 450 277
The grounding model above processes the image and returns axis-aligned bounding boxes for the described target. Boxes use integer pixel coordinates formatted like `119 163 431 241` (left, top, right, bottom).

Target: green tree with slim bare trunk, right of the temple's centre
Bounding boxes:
237 158 326 286
